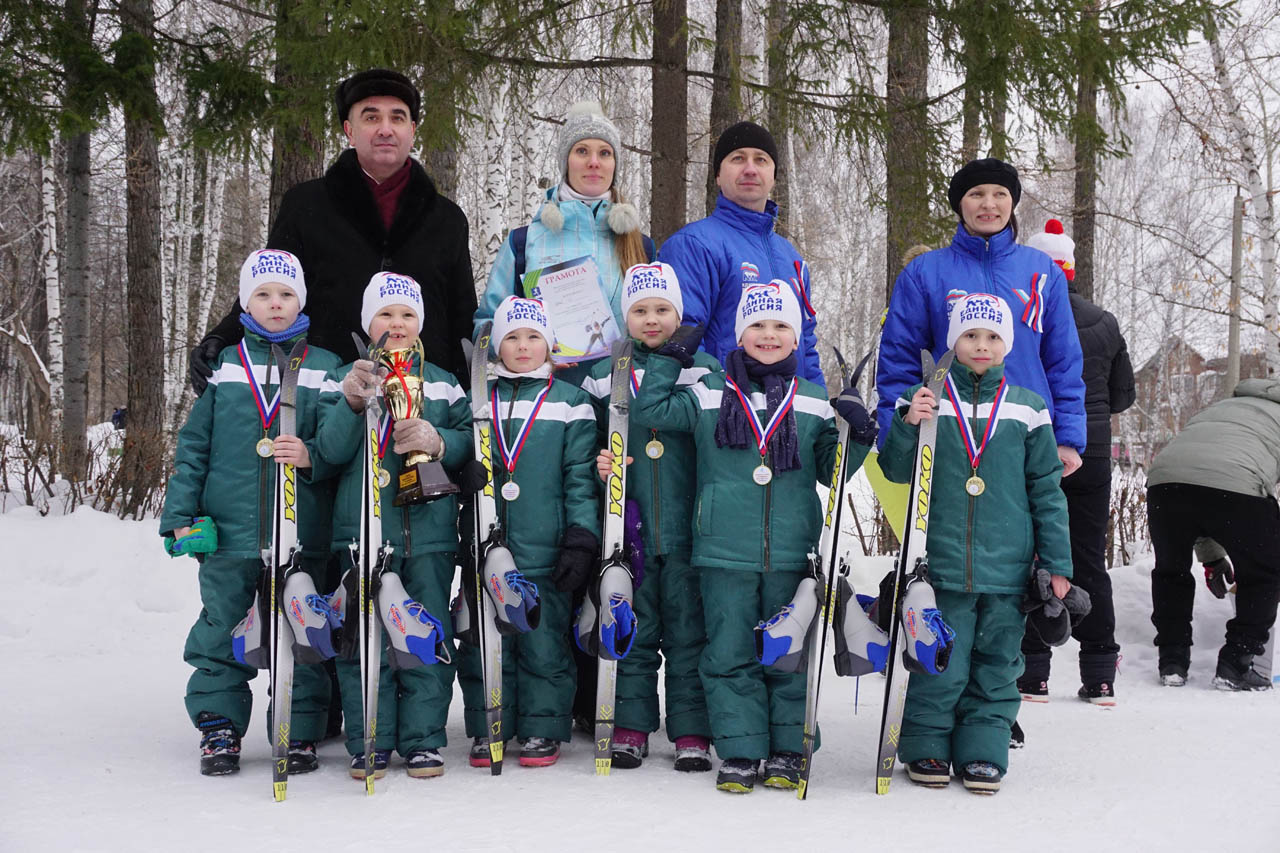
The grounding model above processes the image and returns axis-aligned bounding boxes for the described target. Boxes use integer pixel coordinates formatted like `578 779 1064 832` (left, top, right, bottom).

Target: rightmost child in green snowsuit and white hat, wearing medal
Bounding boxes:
881 293 1071 793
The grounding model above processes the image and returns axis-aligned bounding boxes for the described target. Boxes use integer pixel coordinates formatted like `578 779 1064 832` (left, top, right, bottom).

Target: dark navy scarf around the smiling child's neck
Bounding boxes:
716 348 800 471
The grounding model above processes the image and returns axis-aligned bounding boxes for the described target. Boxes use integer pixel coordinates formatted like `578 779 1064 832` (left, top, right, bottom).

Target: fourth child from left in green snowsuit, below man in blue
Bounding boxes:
582 264 719 771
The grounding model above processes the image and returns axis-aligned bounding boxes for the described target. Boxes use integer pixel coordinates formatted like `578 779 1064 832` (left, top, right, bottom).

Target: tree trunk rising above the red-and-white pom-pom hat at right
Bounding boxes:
1071 0 1101 300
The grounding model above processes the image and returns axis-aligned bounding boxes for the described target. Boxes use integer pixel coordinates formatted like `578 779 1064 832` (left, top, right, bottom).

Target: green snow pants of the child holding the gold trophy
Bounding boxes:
338 551 454 756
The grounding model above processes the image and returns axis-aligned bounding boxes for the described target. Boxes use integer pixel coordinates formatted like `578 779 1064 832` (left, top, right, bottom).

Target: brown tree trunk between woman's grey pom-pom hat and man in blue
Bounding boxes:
649 0 689 243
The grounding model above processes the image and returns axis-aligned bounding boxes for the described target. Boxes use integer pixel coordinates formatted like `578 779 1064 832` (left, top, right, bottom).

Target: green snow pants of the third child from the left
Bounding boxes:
458 569 577 743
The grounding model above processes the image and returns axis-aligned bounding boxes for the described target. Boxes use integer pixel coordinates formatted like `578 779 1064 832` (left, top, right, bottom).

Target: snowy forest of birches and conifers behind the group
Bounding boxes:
0 0 1280 545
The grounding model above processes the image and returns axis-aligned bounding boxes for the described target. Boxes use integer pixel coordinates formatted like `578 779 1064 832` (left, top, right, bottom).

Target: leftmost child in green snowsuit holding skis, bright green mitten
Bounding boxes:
160 250 338 775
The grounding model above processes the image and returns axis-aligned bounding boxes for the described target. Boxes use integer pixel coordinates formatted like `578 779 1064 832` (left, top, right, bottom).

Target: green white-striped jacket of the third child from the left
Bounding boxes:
483 377 600 574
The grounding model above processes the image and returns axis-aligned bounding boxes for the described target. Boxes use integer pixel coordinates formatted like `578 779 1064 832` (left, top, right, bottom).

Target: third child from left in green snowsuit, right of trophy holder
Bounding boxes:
458 296 600 767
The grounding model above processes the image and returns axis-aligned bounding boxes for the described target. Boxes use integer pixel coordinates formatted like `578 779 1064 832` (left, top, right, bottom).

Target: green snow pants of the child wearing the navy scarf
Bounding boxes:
698 566 805 760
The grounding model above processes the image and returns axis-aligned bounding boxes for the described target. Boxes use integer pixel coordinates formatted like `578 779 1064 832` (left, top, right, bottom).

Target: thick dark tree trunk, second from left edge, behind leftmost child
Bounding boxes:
120 0 166 517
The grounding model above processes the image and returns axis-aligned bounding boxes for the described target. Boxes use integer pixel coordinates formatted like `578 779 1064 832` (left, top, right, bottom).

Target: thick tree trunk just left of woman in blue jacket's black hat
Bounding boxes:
884 0 929 301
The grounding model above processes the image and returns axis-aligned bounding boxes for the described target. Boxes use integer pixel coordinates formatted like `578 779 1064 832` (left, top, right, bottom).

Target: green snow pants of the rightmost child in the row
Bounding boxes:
897 589 1027 771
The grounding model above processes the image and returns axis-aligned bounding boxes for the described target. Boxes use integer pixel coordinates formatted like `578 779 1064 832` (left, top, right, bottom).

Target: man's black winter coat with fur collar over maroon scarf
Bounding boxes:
210 149 476 386
